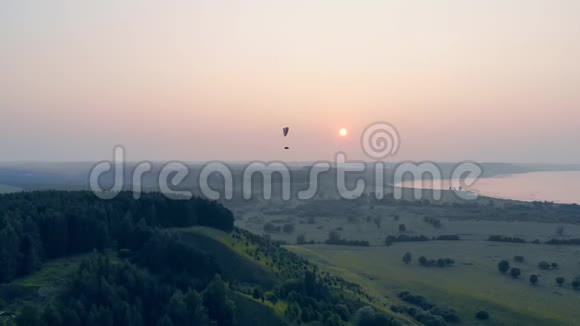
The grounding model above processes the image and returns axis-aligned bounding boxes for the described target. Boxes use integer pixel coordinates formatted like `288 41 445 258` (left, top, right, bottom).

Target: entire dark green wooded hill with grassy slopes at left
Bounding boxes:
0 191 405 326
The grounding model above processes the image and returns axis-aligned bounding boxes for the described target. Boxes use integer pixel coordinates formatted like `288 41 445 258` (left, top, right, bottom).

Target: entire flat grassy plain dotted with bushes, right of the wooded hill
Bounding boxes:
229 195 580 325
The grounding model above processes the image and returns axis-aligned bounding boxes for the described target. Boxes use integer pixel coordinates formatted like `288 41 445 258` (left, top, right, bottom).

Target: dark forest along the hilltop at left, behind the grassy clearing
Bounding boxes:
0 191 233 283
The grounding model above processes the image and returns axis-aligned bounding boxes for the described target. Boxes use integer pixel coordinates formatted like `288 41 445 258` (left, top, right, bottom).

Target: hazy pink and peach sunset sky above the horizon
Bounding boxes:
0 0 580 163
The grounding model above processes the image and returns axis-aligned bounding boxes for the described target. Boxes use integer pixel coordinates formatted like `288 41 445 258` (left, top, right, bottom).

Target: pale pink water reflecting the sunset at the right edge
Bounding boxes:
401 171 580 204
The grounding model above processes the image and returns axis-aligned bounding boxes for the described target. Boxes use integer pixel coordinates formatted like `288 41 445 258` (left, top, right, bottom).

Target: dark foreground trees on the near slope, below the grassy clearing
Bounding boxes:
15 231 236 326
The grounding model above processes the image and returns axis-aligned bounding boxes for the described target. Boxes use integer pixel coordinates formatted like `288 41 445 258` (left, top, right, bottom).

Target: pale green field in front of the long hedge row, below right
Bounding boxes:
288 241 580 325
